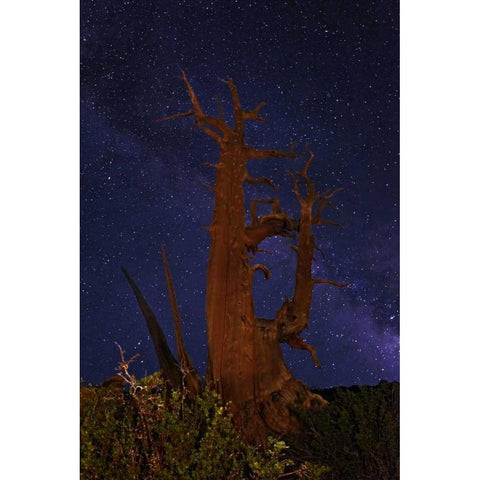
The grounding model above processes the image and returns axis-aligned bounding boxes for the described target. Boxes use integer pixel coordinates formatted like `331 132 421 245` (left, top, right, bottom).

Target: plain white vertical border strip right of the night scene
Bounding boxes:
400 0 480 480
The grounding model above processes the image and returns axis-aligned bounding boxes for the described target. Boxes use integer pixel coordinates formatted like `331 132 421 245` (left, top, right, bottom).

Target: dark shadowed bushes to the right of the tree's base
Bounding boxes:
290 382 399 480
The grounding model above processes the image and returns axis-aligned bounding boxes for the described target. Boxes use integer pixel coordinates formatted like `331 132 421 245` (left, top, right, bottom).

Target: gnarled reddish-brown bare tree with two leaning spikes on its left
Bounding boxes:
123 72 348 441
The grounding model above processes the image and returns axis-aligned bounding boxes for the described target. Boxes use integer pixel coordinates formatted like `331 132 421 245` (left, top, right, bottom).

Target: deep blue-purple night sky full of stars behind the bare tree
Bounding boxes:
80 0 399 388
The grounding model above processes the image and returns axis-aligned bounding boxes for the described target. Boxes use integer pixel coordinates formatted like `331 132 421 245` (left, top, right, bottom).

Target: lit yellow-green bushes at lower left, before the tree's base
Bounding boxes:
80 370 325 480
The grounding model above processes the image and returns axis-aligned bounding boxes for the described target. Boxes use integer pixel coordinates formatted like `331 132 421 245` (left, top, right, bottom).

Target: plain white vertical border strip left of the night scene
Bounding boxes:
0 0 79 480
